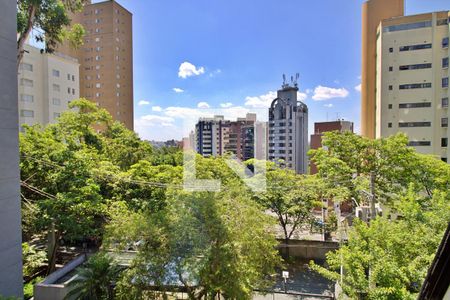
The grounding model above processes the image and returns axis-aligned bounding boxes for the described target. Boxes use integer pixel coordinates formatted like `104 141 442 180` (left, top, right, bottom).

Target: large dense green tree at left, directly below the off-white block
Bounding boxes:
20 99 157 269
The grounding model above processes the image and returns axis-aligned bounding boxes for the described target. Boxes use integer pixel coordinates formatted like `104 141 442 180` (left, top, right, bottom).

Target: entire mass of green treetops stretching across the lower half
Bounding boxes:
20 99 450 299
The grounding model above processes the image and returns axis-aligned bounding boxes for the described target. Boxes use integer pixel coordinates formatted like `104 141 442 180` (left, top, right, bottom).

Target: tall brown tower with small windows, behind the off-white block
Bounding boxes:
60 0 133 130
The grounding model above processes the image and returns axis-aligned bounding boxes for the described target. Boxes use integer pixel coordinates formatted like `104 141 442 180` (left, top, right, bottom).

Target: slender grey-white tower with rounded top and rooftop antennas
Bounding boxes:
269 76 308 174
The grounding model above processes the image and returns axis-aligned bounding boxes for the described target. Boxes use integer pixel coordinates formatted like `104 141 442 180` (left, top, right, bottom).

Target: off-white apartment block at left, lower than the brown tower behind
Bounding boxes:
18 45 80 129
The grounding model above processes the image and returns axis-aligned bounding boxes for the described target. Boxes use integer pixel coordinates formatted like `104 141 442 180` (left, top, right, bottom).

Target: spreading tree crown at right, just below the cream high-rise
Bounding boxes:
310 132 438 209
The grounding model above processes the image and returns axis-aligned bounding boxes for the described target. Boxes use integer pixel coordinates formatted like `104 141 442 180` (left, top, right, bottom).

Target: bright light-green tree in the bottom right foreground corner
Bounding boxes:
313 192 450 299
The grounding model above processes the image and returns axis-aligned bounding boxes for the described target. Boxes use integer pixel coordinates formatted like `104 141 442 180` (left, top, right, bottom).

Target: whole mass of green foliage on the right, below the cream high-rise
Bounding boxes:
312 133 450 299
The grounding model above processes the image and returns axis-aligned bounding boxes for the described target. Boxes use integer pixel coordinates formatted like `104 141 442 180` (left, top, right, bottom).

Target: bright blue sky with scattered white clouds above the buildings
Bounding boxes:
111 0 450 140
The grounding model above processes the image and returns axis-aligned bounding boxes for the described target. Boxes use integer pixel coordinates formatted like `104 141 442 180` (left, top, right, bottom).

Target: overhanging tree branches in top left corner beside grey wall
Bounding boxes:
17 0 86 64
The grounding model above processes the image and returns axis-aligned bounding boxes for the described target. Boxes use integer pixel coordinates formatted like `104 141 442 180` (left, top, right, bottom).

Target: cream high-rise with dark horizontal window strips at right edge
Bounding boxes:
374 11 450 161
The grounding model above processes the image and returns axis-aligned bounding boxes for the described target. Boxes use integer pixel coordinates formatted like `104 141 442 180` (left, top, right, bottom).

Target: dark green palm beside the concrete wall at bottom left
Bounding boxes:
64 253 119 300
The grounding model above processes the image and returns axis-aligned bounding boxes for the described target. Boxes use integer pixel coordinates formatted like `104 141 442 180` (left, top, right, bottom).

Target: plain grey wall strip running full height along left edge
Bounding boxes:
0 0 22 297
